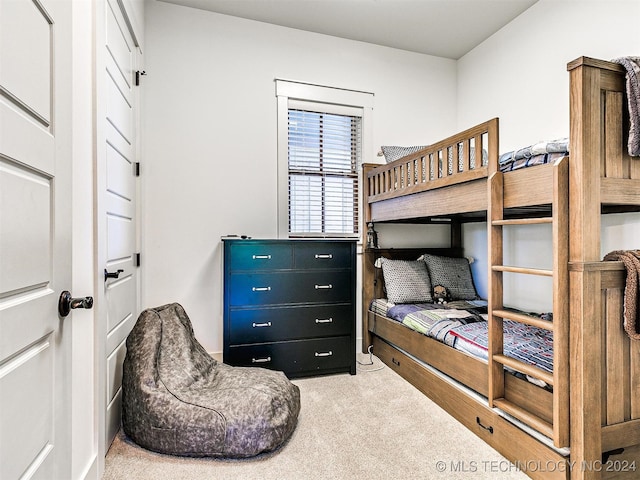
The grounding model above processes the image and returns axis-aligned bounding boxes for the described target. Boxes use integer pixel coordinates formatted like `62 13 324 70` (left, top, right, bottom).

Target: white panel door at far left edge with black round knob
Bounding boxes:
0 0 71 479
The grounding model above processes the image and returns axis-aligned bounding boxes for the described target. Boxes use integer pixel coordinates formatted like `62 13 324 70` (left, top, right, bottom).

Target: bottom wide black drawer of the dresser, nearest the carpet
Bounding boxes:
224 336 355 377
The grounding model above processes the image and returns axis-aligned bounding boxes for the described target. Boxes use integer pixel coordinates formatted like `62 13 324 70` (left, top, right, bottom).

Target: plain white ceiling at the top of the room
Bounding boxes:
162 0 538 60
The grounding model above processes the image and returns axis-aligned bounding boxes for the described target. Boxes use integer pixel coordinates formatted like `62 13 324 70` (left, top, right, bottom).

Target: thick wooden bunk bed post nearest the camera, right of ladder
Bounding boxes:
567 57 605 480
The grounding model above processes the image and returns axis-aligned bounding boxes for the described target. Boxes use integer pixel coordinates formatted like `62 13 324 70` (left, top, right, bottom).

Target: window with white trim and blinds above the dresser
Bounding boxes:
277 80 371 242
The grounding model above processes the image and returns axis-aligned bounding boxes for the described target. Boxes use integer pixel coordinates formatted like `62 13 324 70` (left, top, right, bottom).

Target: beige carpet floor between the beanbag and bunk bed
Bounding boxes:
103 355 528 480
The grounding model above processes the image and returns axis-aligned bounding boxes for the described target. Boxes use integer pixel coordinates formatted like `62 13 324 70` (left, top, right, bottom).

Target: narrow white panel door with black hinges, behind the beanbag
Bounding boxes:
98 0 139 449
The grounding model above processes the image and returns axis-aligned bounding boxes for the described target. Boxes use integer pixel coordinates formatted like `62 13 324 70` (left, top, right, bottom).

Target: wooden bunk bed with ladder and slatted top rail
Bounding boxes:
362 57 640 479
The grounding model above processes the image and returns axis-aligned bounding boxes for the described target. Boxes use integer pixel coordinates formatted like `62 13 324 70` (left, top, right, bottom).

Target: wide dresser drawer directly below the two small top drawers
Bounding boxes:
228 270 353 306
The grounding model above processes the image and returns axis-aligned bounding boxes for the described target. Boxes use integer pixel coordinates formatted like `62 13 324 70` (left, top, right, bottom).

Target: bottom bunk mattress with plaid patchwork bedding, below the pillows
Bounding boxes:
370 299 553 386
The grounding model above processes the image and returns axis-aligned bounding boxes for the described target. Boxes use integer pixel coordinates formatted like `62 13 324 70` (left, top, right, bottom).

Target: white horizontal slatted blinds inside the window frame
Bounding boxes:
287 108 362 237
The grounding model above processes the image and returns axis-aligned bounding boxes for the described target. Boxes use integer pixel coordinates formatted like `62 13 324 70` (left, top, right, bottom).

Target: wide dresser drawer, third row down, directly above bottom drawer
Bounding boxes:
228 304 353 345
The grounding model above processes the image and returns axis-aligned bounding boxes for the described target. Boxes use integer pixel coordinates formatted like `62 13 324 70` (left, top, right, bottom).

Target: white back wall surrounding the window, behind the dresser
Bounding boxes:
142 1 456 352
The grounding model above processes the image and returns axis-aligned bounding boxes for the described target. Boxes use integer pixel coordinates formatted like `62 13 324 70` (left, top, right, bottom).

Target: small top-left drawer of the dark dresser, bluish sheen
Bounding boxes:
226 241 293 271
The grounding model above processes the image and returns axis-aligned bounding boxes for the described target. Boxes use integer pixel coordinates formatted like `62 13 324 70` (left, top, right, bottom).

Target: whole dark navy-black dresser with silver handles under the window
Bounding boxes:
223 239 356 378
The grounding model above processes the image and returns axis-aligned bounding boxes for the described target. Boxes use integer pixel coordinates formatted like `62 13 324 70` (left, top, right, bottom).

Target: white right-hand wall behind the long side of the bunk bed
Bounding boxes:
458 0 640 308
